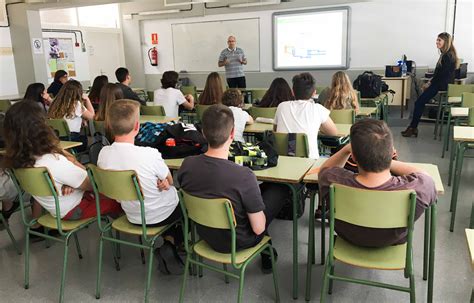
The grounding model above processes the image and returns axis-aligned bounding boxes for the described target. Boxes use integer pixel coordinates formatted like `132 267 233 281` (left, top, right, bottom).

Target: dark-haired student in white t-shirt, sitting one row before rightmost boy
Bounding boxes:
274 73 337 159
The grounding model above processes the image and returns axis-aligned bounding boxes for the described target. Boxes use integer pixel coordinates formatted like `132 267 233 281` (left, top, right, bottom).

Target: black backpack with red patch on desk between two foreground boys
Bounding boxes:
156 122 207 159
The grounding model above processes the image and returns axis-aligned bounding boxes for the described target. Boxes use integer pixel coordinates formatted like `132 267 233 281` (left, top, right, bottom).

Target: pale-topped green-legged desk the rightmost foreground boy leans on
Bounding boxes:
303 158 444 302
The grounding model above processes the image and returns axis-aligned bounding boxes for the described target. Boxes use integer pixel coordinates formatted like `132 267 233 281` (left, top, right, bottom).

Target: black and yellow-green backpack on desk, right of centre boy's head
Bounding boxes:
228 141 268 170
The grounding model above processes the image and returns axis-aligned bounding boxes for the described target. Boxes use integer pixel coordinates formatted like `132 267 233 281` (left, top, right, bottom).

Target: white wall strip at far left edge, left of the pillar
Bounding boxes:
0 27 18 96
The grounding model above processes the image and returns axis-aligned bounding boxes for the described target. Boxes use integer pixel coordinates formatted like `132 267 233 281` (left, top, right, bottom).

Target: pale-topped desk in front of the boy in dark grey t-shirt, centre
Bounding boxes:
165 156 314 299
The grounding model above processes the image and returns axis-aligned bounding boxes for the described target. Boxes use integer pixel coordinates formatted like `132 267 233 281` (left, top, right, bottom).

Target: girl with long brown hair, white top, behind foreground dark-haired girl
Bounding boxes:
48 80 95 151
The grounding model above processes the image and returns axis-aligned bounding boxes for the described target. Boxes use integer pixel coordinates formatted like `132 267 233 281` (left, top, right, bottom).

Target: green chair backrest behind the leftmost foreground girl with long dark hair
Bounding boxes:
13 167 58 197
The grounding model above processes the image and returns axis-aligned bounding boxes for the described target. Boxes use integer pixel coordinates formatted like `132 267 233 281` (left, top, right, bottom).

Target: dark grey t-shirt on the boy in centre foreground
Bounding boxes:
178 155 265 252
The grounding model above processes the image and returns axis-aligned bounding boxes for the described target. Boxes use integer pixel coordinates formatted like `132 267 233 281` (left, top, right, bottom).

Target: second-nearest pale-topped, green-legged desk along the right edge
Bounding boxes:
449 126 474 232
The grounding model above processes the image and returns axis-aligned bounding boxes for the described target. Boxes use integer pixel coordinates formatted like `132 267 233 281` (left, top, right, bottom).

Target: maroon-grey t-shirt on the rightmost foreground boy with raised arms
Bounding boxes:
319 167 436 247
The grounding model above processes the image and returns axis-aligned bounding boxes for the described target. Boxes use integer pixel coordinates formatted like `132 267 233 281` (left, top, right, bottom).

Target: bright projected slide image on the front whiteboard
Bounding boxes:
275 11 346 68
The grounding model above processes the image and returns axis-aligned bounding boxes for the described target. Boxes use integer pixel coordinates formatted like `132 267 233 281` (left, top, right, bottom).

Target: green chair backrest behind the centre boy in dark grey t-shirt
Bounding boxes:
180 190 236 229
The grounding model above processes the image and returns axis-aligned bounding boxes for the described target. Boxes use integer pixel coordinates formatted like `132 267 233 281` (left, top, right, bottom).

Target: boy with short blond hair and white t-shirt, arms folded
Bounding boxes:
97 100 183 273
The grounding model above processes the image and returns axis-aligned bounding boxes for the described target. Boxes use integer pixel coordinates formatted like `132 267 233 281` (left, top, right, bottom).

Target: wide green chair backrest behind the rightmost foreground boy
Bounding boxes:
330 184 416 228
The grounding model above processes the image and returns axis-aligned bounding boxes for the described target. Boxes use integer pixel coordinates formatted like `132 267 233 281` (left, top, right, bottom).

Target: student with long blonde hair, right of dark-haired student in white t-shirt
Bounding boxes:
318 71 359 112
